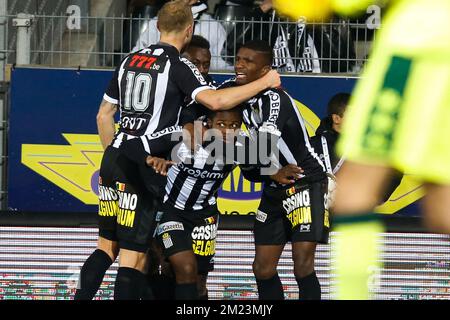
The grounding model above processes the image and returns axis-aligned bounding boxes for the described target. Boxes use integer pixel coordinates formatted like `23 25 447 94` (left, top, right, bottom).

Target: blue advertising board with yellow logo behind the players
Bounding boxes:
8 68 422 215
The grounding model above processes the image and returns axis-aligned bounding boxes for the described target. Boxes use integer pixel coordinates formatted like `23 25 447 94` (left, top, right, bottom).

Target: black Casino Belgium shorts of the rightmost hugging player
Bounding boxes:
254 178 330 245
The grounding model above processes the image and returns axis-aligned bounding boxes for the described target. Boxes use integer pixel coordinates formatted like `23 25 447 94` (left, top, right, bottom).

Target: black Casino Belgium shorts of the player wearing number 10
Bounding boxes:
98 147 162 252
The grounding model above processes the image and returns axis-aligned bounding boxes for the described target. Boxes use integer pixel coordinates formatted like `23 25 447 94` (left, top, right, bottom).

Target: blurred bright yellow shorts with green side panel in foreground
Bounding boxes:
337 0 450 184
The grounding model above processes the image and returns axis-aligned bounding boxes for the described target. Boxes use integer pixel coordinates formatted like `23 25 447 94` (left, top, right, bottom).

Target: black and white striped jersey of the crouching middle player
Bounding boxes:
164 143 236 211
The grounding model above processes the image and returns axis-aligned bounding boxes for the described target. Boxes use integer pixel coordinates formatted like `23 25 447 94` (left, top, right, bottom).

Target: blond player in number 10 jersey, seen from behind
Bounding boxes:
75 0 280 299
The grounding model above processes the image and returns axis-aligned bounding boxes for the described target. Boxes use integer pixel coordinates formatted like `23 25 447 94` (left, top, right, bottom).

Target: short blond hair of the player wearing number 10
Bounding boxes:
158 0 194 33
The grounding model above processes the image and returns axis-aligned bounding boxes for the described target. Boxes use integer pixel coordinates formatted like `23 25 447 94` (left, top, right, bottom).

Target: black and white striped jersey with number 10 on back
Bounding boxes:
103 43 211 148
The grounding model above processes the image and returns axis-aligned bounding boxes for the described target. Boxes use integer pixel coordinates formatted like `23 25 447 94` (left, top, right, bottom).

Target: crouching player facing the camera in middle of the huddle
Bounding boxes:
153 107 302 299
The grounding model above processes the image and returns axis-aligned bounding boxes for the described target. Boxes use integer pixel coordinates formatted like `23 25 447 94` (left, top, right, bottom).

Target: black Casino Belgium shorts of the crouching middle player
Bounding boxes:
157 205 219 274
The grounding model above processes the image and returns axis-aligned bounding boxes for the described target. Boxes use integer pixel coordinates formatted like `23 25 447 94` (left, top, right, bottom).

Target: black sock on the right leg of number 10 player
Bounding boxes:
114 267 145 300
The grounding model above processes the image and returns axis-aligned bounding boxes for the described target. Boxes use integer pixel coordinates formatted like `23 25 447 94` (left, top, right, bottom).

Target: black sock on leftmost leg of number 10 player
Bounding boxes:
74 249 113 300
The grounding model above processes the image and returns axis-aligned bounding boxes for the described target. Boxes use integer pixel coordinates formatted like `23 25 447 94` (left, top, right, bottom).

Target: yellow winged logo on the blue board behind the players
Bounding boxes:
21 101 424 215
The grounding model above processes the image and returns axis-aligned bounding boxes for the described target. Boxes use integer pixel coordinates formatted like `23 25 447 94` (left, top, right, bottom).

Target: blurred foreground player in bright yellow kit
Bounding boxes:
274 0 450 299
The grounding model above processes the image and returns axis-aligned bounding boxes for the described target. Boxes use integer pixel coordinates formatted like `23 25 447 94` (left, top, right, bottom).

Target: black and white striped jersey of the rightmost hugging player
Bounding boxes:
220 80 325 187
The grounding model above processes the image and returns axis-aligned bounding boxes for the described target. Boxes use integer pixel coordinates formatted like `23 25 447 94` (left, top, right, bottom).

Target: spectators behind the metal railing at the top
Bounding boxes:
123 0 371 73
